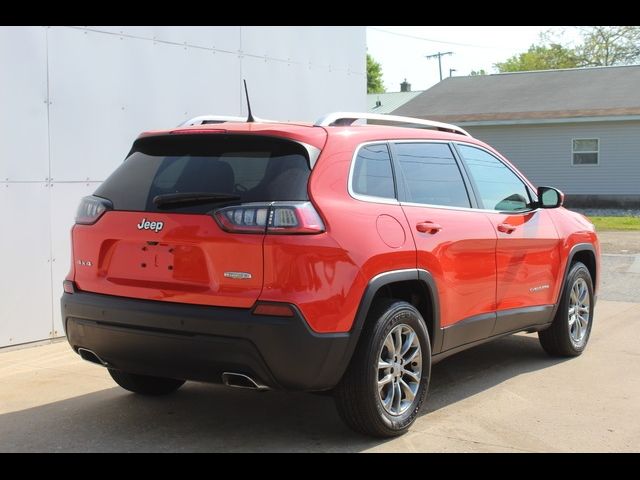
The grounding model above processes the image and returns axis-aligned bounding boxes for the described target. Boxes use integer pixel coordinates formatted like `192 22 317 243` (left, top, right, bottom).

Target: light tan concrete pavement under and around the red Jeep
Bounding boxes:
0 232 640 452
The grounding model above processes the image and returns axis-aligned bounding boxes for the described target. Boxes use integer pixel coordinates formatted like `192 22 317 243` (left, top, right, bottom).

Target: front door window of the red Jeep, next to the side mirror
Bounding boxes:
458 144 531 212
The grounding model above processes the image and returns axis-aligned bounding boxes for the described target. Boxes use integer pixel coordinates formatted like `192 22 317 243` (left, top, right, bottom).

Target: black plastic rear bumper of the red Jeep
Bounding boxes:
61 292 351 391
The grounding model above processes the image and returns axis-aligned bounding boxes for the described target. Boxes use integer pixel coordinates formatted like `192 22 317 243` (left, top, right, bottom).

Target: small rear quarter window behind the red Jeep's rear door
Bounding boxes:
351 143 396 198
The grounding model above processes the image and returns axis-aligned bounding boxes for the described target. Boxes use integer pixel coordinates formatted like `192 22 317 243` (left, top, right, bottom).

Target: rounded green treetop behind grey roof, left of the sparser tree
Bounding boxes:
495 43 581 73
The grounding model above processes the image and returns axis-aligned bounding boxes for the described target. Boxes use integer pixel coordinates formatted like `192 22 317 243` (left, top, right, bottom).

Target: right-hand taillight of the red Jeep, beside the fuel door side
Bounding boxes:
213 202 325 235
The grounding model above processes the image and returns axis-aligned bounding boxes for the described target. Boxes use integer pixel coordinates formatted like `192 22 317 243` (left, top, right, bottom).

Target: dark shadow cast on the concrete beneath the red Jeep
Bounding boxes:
0 335 558 452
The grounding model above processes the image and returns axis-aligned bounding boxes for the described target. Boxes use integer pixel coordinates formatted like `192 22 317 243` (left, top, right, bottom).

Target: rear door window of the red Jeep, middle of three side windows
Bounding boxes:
394 143 471 207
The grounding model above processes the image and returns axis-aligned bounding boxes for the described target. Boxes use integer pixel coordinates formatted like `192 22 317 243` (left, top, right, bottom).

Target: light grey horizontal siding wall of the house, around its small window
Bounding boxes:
465 121 640 195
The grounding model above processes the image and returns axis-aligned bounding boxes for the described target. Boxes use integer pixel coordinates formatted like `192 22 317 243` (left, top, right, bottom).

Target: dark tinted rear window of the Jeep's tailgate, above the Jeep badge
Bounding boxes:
95 134 310 213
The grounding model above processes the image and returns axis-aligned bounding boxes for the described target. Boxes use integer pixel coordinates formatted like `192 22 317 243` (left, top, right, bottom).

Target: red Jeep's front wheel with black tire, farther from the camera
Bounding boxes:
538 262 594 357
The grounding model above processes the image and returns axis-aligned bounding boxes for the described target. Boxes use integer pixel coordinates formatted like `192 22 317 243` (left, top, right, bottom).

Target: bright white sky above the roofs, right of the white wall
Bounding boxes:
367 26 576 92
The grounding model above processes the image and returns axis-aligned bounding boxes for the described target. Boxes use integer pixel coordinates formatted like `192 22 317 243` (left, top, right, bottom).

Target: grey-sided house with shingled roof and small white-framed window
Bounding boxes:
392 66 640 208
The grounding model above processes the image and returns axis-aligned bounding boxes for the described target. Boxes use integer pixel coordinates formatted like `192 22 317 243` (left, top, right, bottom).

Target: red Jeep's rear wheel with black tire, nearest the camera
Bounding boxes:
334 299 431 437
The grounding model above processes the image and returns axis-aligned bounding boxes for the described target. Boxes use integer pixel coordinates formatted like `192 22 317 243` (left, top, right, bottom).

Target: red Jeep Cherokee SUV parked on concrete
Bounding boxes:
61 113 599 436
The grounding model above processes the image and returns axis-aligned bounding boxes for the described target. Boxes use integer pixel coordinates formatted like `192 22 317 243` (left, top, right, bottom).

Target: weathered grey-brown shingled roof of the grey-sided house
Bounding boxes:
393 65 640 123
